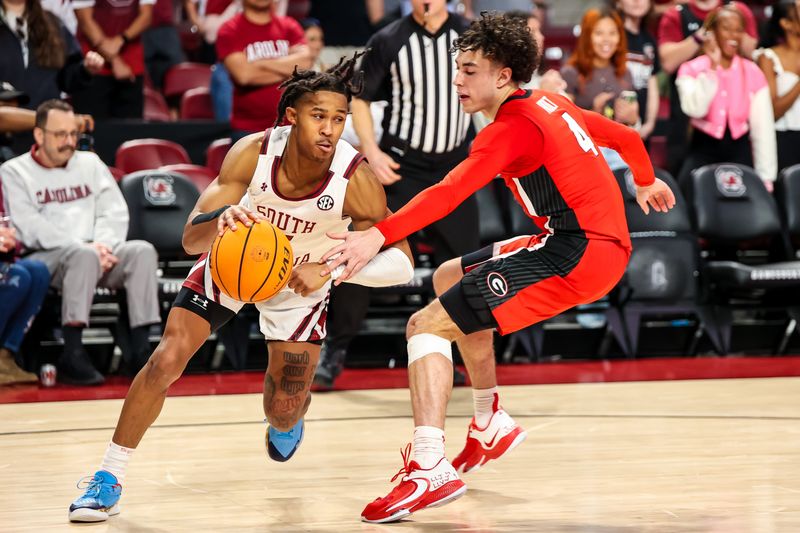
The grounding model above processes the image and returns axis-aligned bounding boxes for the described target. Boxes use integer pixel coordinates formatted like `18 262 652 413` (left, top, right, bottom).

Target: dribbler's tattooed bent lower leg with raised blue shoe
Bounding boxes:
264 341 320 462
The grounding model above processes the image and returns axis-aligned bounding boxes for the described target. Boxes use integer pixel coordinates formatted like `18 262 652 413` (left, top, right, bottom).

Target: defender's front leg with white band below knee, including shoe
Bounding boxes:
361 299 467 522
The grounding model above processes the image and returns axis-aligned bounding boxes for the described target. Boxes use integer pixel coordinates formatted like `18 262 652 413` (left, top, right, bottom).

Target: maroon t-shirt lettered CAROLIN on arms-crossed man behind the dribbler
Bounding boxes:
217 13 305 131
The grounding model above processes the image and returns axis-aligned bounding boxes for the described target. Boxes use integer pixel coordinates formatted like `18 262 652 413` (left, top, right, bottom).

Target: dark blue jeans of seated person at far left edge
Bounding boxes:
0 259 50 353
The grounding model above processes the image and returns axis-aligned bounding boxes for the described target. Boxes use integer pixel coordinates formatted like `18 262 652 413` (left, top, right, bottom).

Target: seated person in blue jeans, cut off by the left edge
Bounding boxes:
0 210 50 385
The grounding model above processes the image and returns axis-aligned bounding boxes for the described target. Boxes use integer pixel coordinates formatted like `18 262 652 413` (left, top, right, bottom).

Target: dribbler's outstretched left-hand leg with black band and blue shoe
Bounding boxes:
69 288 235 522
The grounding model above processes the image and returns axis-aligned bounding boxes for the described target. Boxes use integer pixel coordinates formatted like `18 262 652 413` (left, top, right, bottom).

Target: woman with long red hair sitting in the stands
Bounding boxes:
561 7 639 126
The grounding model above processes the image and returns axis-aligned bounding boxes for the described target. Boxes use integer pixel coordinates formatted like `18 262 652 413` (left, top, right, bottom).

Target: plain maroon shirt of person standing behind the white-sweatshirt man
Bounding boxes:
72 0 156 76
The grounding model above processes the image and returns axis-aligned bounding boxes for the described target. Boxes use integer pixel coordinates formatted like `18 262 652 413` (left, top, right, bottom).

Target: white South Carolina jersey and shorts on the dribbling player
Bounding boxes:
184 126 364 341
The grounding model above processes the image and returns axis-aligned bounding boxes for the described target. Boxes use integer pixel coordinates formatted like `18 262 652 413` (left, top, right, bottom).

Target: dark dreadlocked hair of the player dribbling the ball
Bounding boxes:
275 50 367 127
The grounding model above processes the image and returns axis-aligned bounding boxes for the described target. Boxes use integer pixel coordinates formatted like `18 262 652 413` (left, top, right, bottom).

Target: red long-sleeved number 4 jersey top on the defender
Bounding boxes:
375 90 655 254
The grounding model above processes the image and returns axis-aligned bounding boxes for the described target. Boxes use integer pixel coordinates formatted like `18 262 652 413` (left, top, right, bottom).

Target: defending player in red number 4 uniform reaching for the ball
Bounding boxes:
323 14 675 522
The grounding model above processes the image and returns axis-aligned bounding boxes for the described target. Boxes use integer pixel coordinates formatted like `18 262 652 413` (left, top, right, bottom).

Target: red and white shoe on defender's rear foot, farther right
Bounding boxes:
453 409 528 473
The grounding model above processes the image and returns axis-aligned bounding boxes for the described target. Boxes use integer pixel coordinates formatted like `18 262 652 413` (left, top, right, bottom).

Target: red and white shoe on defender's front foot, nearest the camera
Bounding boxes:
361 444 467 523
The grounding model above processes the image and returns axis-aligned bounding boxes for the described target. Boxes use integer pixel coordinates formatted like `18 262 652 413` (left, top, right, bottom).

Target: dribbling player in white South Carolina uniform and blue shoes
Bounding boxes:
69 56 414 522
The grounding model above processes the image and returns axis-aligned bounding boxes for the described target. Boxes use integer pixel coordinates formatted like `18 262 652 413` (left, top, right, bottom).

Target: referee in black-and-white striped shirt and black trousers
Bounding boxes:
315 0 479 387
